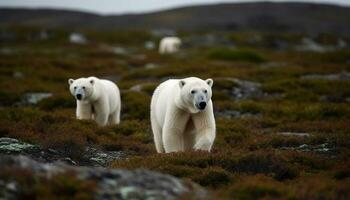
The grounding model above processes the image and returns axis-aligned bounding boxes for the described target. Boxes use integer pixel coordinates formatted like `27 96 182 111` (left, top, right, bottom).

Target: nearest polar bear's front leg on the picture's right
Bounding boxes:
193 102 216 151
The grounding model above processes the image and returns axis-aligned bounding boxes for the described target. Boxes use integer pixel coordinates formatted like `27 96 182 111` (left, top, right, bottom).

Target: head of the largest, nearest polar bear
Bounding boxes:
179 77 213 113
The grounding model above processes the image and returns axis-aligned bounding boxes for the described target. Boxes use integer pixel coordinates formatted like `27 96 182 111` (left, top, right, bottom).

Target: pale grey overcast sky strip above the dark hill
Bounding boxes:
0 0 350 14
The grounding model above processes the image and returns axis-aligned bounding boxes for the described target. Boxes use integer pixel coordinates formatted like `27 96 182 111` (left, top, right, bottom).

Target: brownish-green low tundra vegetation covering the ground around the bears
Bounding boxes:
0 27 350 199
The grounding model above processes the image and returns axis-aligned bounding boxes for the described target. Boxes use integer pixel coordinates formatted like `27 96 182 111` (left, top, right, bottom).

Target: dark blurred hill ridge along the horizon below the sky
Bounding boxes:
0 2 350 35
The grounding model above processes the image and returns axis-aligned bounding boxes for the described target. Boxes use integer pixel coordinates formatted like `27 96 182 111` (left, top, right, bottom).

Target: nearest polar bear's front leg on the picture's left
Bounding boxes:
162 108 190 153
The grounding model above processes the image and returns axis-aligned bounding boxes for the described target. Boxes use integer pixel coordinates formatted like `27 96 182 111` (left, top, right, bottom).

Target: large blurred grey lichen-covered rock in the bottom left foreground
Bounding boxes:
0 156 207 200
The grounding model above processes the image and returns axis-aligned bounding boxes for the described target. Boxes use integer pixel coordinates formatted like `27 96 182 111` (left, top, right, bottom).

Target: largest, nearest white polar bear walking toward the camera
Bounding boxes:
151 77 216 153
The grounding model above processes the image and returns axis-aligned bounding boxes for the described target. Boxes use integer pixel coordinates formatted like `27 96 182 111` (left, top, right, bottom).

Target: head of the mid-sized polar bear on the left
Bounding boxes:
68 77 96 101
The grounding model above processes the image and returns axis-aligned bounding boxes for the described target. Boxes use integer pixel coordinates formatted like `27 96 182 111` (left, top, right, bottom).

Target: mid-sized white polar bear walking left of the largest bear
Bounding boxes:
68 77 121 126
